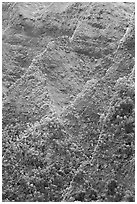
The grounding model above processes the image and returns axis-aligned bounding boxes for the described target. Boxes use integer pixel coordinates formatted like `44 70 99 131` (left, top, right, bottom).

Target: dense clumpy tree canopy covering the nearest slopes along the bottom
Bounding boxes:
3 74 135 202
